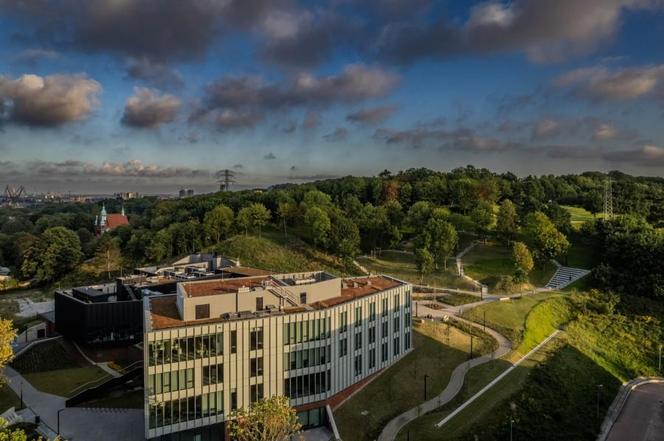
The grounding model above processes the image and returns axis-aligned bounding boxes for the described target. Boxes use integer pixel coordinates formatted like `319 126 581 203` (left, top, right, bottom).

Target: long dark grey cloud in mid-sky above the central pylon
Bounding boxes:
190 64 399 127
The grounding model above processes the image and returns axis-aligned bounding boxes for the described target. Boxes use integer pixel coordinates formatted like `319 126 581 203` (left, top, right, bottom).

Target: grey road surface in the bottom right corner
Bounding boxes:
607 383 664 441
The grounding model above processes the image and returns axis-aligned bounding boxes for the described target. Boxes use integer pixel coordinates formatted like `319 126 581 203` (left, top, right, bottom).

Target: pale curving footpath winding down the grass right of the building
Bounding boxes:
378 305 512 441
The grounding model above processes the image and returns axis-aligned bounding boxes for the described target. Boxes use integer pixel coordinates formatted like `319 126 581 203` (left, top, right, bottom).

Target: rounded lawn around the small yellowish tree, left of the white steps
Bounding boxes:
462 241 556 293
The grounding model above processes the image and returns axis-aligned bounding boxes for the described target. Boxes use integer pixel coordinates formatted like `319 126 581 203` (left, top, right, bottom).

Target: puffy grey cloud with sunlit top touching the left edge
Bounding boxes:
0 74 101 127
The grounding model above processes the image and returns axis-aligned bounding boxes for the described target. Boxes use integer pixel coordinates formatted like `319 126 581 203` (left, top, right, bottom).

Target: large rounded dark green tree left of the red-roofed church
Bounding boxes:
21 227 83 282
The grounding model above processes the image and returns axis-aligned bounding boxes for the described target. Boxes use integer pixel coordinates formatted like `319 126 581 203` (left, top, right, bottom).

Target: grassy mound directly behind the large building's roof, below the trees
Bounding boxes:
214 231 359 275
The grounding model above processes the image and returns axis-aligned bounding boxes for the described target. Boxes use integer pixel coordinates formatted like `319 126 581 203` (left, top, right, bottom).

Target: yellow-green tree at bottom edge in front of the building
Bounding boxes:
228 396 302 441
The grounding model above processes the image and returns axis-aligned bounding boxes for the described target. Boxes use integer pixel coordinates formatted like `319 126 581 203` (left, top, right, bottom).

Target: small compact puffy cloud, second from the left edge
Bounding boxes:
122 87 180 129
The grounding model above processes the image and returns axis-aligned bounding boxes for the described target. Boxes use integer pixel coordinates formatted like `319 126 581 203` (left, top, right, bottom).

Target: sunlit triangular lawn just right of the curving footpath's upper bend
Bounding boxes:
463 292 562 347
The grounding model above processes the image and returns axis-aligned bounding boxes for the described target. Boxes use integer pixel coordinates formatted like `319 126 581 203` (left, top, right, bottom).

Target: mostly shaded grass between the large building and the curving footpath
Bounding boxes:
335 321 496 441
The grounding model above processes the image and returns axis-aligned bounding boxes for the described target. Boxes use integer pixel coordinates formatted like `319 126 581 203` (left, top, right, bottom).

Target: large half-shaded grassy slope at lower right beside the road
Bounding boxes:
400 293 664 441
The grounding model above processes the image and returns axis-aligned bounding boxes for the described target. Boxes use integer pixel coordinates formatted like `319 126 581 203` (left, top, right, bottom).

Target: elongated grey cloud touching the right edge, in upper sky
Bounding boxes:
554 64 664 101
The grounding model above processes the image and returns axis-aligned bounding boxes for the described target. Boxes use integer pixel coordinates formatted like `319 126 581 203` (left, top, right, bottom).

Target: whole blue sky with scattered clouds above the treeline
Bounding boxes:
0 0 664 193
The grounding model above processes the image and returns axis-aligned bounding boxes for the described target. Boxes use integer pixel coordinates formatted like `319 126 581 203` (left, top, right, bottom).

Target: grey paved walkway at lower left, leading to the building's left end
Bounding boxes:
5 367 144 441
